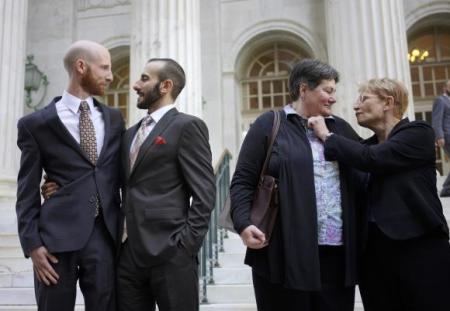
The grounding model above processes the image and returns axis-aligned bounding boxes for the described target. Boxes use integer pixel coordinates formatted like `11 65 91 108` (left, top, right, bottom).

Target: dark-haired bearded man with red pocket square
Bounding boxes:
117 58 215 311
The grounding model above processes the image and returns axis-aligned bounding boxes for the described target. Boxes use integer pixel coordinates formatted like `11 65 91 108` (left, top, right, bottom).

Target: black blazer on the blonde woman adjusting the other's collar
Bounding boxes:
325 118 448 240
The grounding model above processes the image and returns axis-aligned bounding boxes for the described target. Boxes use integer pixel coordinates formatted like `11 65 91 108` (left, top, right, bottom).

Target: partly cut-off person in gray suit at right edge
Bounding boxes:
431 80 450 197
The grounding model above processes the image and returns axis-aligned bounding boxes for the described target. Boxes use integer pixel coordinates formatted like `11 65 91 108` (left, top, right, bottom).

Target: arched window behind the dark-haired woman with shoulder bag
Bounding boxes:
236 33 312 137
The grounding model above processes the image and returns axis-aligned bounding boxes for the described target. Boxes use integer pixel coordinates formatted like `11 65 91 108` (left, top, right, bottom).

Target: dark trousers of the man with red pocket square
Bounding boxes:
117 241 199 311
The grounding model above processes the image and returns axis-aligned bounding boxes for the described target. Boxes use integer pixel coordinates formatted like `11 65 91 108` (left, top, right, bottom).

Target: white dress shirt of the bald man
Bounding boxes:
56 91 105 156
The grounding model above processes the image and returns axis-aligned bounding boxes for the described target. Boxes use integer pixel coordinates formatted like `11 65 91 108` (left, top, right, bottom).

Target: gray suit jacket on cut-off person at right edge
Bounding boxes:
431 95 450 152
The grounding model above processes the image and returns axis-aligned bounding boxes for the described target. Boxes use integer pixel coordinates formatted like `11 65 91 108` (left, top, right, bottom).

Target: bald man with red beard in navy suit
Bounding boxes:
16 41 124 311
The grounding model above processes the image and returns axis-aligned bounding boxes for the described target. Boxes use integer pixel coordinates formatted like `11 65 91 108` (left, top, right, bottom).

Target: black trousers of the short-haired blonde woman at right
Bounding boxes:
360 223 450 311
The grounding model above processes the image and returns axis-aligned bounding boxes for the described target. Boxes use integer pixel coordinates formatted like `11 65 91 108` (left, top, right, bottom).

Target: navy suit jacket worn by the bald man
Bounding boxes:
16 97 124 256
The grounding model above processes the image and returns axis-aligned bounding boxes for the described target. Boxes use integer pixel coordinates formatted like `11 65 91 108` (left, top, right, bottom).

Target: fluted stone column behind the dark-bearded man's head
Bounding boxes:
130 0 202 124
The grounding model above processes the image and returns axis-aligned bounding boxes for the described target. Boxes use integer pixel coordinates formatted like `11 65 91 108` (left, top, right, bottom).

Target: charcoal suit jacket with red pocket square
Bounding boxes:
121 108 215 267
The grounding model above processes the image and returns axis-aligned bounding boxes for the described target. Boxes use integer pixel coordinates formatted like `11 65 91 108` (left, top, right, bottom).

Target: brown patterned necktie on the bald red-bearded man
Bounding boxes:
79 101 97 165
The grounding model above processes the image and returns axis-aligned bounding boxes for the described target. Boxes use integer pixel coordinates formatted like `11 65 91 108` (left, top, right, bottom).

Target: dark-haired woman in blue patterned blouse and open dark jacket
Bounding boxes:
230 59 361 311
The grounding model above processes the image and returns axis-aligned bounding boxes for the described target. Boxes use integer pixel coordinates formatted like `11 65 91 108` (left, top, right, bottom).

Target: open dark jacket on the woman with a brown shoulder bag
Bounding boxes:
230 111 362 291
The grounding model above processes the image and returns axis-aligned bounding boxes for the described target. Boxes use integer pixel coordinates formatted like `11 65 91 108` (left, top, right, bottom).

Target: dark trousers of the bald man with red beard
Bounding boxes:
35 217 116 311
